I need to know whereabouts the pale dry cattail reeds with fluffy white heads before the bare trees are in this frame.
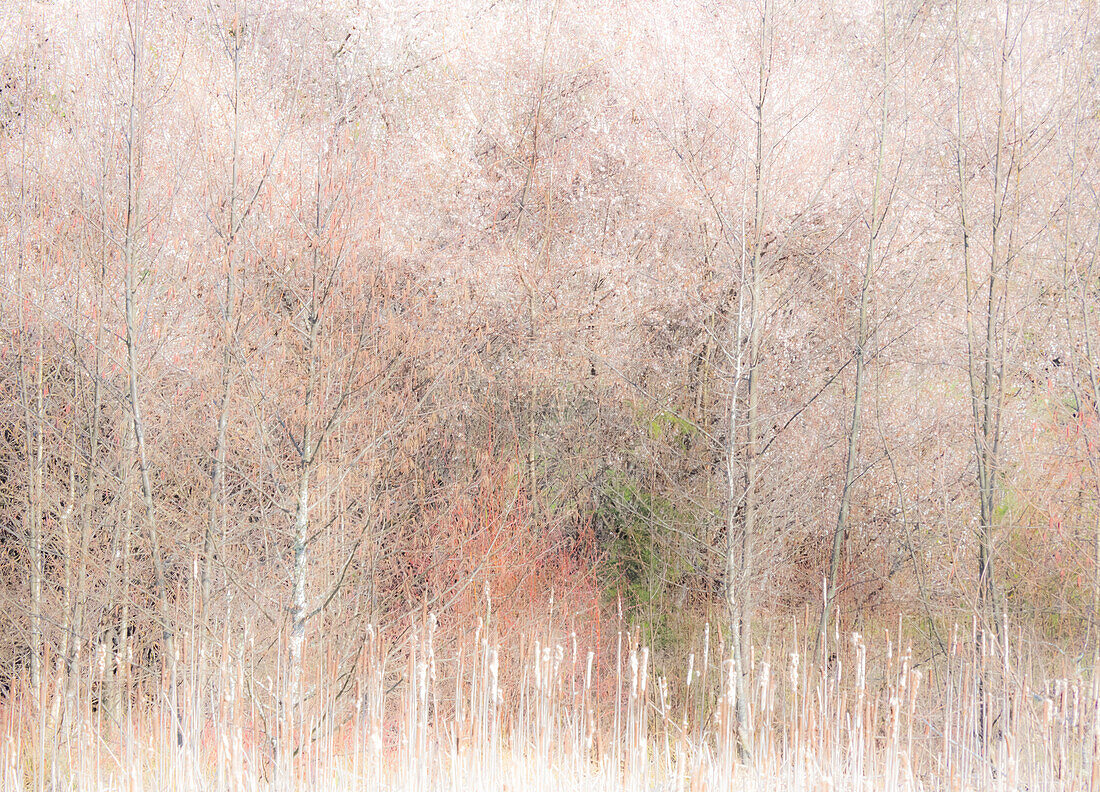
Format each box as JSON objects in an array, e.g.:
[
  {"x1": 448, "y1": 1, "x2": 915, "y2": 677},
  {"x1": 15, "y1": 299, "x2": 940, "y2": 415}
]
[{"x1": 0, "y1": 617, "x2": 1100, "y2": 792}]
